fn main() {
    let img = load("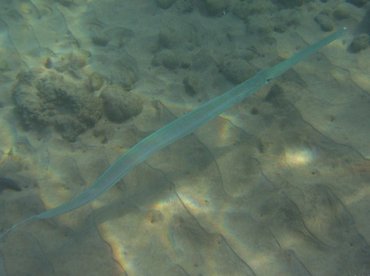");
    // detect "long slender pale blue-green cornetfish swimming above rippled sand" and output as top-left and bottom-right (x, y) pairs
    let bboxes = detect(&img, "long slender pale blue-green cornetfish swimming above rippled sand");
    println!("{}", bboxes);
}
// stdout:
(0, 28), (346, 239)
